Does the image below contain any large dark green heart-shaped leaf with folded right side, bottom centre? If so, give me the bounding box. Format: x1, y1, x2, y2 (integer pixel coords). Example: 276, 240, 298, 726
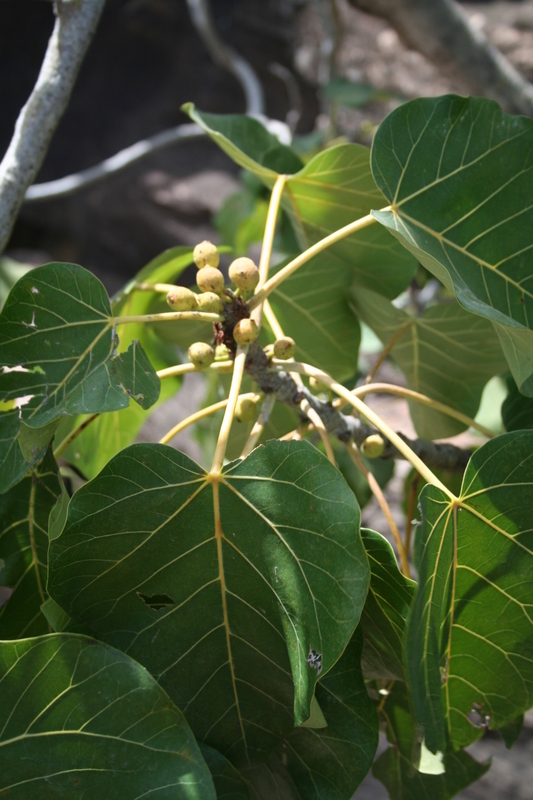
48, 442, 368, 766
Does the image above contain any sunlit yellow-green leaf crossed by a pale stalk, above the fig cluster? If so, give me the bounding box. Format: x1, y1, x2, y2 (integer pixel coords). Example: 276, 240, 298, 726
283, 144, 416, 298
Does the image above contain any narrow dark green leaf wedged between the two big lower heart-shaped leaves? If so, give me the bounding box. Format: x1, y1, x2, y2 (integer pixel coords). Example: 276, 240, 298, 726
361, 528, 416, 680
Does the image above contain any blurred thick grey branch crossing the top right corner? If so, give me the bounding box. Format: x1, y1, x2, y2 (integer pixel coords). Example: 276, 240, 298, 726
348, 0, 533, 116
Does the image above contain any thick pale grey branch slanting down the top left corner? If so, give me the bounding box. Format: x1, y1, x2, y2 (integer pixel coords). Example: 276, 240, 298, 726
0, 0, 105, 252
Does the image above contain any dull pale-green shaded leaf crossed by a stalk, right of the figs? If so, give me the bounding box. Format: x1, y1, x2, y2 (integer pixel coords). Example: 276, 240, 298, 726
352, 289, 506, 439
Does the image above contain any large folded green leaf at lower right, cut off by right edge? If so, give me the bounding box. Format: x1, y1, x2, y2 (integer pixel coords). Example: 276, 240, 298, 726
406, 431, 533, 752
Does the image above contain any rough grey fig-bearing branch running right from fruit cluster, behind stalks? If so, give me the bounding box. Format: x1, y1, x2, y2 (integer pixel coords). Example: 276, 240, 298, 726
246, 344, 472, 472
